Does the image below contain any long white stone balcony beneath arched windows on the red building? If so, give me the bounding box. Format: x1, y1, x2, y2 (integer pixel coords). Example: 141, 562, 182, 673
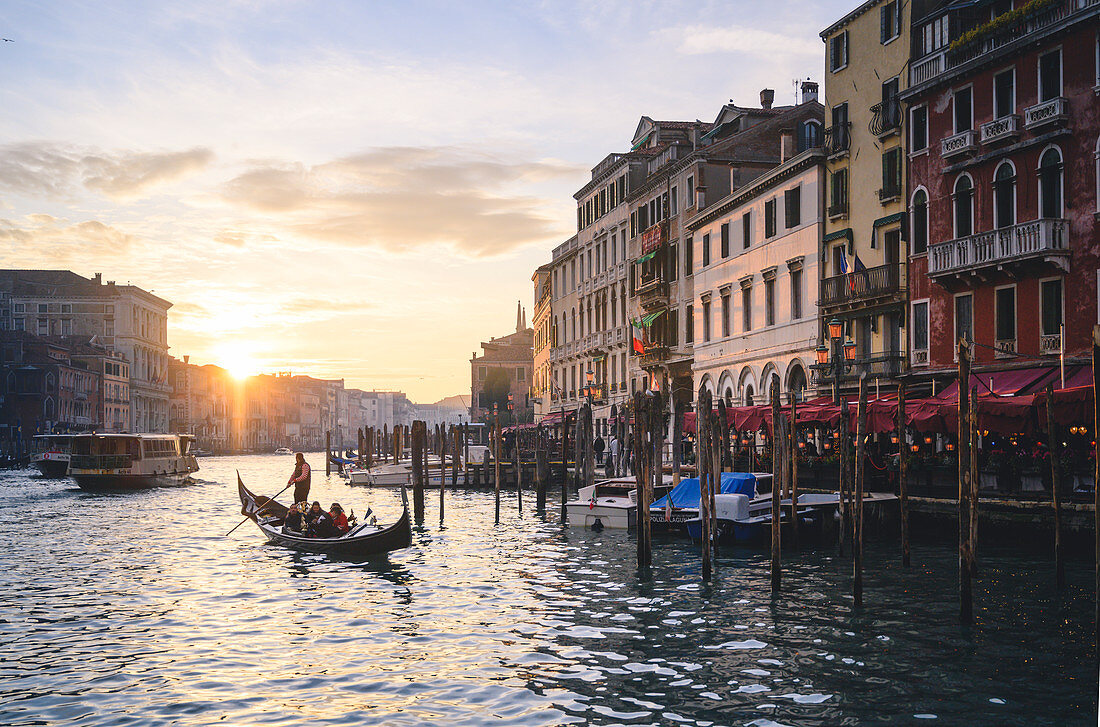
928, 219, 1069, 277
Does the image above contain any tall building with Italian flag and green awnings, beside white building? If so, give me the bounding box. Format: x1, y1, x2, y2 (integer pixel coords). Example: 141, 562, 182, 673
627, 90, 823, 413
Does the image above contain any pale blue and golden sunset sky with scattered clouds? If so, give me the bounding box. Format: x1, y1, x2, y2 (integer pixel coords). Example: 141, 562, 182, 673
0, 0, 856, 401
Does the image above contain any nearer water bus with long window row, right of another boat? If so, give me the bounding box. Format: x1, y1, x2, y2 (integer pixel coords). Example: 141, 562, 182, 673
69, 434, 199, 489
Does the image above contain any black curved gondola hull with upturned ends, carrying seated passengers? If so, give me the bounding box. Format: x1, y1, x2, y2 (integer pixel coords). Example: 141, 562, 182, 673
237, 474, 413, 558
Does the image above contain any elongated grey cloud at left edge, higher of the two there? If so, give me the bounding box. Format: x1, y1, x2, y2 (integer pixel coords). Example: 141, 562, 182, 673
0, 142, 213, 200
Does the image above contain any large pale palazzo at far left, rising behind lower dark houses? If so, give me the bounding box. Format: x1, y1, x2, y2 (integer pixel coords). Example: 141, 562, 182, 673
0, 271, 172, 432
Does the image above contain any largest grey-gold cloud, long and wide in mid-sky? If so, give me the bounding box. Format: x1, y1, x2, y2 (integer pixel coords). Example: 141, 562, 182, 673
222, 146, 583, 257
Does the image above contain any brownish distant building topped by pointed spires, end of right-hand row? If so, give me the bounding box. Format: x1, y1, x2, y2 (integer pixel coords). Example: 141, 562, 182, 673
470, 305, 535, 422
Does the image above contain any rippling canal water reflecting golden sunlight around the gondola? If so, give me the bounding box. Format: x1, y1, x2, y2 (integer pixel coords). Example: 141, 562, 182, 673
0, 455, 1098, 727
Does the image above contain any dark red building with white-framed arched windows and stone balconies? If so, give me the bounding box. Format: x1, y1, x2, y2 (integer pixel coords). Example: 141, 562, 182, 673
902, 0, 1100, 386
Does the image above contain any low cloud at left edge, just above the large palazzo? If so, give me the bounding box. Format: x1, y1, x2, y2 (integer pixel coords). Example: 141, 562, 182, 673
0, 214, 138, 258
